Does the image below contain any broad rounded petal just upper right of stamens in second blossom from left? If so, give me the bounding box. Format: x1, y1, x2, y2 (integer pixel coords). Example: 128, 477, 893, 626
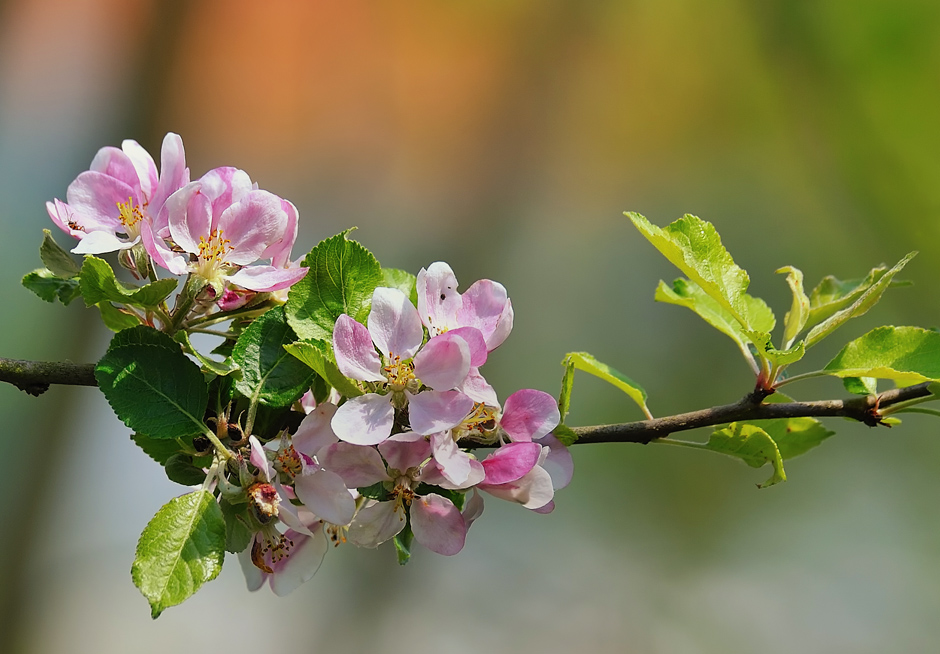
216, 191, 287, 266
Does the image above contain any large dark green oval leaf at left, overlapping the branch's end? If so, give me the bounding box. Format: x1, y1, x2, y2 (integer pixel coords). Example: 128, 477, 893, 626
95, 325, 209, 438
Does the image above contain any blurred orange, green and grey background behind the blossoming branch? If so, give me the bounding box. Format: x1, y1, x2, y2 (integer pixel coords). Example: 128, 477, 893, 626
0, 0, 940, 654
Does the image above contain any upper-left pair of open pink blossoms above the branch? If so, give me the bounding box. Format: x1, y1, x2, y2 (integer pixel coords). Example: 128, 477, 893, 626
46, 133, 307, 310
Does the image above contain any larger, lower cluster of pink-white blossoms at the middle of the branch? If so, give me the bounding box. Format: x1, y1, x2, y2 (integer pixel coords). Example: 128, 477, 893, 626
235, 262, 573, 594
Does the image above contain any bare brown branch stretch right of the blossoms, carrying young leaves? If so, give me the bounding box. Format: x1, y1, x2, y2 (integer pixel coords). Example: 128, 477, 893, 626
572, 382, 932, 444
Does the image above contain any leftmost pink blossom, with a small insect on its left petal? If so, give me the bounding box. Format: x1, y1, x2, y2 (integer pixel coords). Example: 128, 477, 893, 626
46, 132, 189, 254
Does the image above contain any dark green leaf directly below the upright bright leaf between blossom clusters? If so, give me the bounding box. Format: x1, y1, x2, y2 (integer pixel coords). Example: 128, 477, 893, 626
232, 307, 313, 407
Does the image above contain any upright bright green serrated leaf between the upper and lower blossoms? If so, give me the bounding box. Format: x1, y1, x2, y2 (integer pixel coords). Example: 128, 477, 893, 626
285, 230, 385, 341
